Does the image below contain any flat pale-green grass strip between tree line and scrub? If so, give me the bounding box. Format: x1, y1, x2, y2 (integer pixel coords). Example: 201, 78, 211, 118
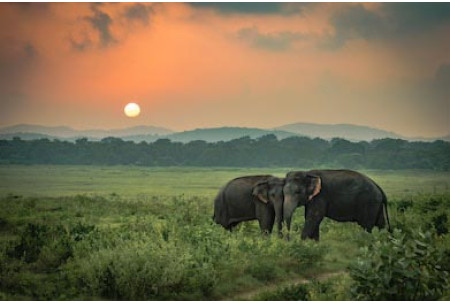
0, 165, 450, 198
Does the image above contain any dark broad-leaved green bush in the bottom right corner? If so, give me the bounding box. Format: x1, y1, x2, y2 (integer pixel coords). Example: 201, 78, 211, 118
349, 229, 449, 300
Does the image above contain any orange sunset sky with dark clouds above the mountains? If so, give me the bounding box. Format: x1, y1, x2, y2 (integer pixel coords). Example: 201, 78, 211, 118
0, 3, 450, 137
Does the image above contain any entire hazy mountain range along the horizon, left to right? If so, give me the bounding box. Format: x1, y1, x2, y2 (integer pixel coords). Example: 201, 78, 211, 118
0, 123, 450, 142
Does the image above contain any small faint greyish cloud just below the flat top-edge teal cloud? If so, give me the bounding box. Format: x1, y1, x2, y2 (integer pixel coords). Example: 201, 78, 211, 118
238, 27, 304, 51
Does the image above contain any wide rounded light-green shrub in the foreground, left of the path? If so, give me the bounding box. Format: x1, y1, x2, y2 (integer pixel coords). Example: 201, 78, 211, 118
66, 238, 219, 300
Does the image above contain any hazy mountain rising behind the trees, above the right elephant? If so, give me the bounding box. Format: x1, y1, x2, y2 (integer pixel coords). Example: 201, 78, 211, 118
275, 123, 407, 141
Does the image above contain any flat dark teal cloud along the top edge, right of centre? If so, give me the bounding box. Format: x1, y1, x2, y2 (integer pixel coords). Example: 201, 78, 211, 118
190, 2, 306, 15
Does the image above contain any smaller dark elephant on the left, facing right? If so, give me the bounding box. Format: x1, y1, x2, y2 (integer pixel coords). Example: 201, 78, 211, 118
213, 175, 284, 234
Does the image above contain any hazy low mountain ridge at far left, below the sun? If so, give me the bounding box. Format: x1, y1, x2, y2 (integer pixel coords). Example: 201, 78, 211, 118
0, 124, 172, 139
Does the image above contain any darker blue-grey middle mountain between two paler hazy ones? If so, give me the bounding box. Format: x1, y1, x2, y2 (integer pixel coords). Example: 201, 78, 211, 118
164, 127, 297, 142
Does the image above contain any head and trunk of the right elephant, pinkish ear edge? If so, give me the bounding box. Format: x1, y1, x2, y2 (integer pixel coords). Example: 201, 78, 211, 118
283, 171, 322, 231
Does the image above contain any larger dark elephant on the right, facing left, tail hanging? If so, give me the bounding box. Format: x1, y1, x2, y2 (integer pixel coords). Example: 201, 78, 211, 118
283, 170, 390, 241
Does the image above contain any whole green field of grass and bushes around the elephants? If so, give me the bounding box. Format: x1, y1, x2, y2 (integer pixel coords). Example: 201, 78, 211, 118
0, 165, 450, 300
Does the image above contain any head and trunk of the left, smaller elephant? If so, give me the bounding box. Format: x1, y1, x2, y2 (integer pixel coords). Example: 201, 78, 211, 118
253, 177, 285, 234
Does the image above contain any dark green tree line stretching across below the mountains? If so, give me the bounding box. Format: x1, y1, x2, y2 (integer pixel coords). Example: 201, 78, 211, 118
0, 135, 450, 171
